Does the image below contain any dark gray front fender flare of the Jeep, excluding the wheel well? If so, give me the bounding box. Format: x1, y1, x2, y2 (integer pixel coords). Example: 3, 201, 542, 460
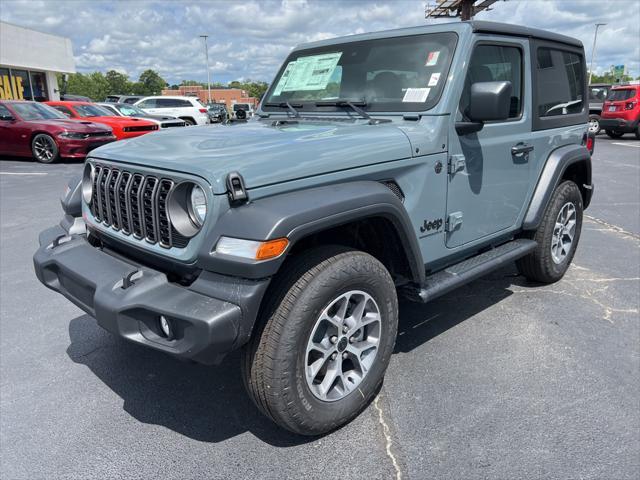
197, 181, 425, 282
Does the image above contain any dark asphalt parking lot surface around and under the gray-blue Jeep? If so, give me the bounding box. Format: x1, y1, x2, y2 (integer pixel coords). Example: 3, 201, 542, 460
0, 135, 640, 480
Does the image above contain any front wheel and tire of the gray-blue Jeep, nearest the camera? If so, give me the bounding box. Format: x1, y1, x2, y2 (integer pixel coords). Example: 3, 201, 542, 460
242, 247, 398, 435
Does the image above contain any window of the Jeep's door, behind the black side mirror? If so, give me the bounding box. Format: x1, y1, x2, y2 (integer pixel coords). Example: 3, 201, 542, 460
460, 45, 522, 118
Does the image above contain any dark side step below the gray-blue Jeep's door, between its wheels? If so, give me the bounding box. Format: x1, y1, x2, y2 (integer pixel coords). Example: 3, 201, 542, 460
411, 238, 537, 302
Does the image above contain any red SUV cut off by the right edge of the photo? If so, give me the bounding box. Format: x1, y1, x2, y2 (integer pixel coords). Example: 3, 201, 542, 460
600, 85, 640, 140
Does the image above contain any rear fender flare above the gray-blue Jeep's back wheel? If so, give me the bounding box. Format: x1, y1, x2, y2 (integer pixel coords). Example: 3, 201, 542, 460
522, 145, 593, 230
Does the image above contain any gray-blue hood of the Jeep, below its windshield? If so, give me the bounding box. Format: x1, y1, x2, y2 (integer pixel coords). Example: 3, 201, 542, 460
91, 119, 411, 193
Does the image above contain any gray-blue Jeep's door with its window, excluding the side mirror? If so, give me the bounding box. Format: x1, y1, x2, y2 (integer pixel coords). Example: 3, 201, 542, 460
446, 37, 535, 248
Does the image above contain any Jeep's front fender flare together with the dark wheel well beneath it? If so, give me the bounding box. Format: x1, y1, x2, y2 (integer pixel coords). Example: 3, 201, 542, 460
198, 181, 424, 283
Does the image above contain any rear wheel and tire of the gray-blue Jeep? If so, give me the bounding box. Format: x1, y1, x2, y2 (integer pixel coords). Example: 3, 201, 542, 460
516, 181, 583, 283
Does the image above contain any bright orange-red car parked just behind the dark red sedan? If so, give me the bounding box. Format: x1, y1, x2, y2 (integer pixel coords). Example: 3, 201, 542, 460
45, 102, 158, 140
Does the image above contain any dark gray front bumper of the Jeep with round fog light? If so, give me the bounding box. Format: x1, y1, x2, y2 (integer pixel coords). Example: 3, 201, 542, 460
33, 227, 269, 364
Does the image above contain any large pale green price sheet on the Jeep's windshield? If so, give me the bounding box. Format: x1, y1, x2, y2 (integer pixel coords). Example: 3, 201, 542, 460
274, 52, 342, 95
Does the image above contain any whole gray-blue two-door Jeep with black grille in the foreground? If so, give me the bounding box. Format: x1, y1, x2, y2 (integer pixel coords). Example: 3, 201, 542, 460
34, 22, 593, 435
